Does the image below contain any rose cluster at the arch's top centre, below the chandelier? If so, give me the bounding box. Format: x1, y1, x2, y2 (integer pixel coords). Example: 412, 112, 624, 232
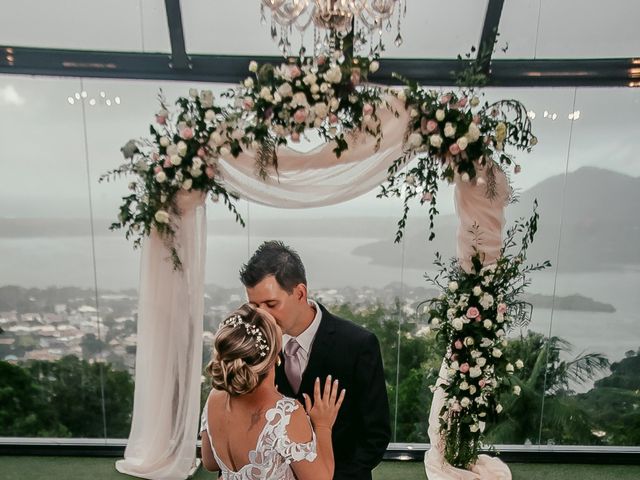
224, 52, 382, 176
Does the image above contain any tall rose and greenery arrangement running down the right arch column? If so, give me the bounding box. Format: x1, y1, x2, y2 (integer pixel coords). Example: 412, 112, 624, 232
426, 202, 550, 469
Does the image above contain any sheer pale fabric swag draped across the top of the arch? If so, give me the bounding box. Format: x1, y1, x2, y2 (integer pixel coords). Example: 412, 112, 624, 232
219, 97, 409, 208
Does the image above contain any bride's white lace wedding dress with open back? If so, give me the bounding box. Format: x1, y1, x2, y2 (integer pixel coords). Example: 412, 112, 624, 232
200, 397, 316, 480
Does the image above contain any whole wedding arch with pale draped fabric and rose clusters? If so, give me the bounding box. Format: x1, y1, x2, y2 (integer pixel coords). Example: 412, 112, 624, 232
101, 57, 545, 480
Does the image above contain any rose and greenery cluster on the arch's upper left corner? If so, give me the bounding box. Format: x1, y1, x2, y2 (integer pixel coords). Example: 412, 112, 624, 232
100, 89, 244, 269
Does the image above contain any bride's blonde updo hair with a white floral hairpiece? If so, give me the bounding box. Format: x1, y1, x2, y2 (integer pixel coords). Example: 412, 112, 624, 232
206, 303, 282, 396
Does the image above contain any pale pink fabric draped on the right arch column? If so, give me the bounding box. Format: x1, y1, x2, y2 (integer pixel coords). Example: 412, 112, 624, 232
424, 168, 511, 480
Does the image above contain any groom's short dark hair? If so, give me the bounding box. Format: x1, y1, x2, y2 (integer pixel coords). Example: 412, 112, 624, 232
240, 240, 307, 293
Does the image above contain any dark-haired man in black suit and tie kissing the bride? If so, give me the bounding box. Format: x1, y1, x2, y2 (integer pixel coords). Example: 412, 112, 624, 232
240, 241, 391, 480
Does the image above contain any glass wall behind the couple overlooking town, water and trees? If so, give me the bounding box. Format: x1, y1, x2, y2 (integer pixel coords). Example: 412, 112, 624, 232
0, 76, 640, 446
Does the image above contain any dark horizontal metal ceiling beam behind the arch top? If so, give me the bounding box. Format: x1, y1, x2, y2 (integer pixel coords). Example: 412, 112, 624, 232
0, 46, 640, 87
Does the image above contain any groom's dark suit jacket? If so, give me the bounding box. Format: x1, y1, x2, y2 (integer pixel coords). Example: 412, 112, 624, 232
276, 305, 391, 480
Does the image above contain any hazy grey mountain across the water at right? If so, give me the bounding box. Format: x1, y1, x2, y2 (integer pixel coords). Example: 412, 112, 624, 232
353, 167, 640, 272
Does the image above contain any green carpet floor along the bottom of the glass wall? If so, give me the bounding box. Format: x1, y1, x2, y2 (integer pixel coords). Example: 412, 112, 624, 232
0, 456, 640, 480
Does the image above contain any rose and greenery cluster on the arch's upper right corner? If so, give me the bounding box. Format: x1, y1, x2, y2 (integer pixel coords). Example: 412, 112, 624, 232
378, 77, 538, 242
